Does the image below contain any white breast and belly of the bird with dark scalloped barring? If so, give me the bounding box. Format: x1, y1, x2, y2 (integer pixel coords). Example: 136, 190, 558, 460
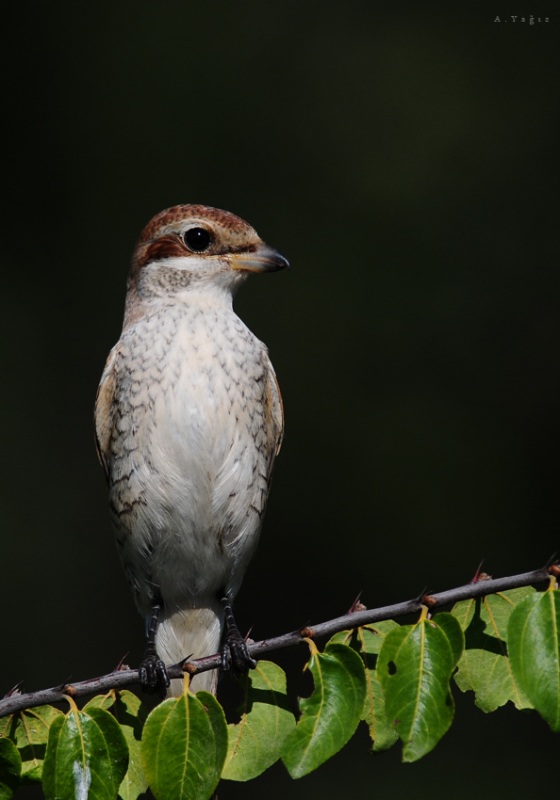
103, 297, 277, 611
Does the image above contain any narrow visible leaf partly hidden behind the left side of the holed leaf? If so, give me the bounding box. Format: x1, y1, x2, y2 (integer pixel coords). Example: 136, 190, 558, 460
329, 620, 399, 753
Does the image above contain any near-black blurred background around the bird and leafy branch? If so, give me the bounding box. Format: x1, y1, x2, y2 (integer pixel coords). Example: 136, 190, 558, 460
0, 0, 560, 800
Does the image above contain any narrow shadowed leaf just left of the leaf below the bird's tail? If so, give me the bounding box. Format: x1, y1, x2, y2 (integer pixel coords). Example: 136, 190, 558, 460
111, 689, 148, 800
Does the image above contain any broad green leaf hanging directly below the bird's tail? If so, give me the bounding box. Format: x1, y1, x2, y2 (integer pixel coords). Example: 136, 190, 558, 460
141, 692, 227, 800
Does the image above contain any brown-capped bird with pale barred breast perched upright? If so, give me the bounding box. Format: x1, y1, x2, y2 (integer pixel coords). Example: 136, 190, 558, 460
95, 204, 289, 696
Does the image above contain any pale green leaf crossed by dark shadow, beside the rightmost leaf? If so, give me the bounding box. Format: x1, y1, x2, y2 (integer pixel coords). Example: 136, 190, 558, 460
451, 586, 535, 712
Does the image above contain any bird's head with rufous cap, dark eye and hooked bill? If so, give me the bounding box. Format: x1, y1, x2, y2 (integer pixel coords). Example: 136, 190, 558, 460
129, 205, 288, 314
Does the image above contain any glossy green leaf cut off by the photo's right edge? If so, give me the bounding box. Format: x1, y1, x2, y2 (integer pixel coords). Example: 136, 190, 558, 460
508, 584, 560, 731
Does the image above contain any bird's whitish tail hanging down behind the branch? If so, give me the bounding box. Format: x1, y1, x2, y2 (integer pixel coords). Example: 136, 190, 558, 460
156, 601, 224, 697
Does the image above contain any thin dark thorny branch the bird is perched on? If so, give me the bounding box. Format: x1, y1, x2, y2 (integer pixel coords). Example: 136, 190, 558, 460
0, 562, 560, 717
